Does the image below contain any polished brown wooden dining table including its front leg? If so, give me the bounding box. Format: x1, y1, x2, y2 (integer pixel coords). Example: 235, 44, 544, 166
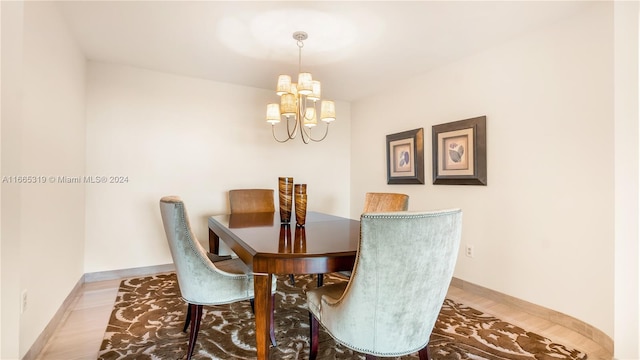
208, 211, 360, 360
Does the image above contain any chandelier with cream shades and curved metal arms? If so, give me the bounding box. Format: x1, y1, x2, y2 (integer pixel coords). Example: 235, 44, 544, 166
267, 31, 336, 144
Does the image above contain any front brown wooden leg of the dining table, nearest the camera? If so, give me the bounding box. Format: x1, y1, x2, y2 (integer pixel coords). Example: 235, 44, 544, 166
253, 274, 273, 360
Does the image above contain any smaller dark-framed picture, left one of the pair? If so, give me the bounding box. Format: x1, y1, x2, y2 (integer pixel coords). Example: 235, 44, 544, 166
387, 128, 424, 184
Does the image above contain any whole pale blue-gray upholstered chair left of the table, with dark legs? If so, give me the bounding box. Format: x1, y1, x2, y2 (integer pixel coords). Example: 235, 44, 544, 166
160, 196, 276, 359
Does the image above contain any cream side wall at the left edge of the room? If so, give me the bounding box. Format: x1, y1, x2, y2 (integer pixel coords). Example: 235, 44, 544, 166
2, 2, 85, 359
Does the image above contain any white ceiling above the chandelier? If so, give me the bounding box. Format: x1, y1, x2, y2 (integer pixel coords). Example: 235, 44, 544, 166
56, 0, 591, 101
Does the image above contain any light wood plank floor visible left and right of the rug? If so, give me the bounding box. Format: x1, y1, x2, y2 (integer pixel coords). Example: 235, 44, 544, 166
36, 274, 612, 360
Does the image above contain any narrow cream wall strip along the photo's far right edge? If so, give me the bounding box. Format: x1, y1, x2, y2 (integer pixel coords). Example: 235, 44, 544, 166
614, 1, 640, 359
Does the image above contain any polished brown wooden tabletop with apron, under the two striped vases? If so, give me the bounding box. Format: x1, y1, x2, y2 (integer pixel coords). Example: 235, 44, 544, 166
209, 211, 360, 274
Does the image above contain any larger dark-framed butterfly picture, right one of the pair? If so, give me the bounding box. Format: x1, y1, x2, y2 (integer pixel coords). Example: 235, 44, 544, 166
431, 116, 487, 186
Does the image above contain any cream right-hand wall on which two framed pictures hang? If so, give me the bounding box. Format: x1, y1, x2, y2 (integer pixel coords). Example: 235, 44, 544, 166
351, 4, 614, 336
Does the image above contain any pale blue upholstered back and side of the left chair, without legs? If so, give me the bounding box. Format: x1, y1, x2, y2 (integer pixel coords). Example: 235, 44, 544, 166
160, 196, 253, 304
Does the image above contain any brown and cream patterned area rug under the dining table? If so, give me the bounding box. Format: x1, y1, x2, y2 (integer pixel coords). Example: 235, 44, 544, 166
99, 273, 586, 360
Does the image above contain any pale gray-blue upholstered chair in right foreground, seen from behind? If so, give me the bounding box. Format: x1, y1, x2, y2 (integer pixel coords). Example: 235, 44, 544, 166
307, 209, 462, 359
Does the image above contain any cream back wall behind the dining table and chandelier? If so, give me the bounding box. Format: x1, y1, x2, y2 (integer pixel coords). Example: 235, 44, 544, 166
85, 62, 350, 273
